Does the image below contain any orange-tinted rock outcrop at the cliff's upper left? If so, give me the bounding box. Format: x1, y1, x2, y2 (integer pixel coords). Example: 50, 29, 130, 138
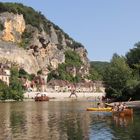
0, 12, 25, 42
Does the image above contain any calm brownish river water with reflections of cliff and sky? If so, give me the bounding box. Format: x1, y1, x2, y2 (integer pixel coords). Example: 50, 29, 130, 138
0, 101, 140, 140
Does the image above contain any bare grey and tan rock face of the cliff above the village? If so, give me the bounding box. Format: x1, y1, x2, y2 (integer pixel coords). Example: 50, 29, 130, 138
0, 3, 89, 79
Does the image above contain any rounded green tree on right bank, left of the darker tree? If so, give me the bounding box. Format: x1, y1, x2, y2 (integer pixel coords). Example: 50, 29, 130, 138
104, 54, 132, 99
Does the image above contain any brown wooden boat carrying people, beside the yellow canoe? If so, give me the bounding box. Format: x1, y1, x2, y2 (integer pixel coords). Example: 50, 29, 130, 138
112, 108, 133, 117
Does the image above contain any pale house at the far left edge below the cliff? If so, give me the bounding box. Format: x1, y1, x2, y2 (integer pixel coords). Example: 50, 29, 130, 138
0, 63, 10, 86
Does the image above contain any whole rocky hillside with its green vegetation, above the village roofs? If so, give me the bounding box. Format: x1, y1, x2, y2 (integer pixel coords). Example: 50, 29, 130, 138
0, 2, 89, 87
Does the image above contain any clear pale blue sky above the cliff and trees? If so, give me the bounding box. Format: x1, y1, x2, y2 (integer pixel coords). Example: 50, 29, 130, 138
0, 0, 140, 61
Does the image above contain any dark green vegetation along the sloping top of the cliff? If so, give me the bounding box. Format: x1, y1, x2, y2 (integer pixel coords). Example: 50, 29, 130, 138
0, 2, 84, 49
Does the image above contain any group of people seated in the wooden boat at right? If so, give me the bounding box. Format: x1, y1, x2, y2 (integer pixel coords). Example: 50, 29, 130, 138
113, 102, 127, 111
